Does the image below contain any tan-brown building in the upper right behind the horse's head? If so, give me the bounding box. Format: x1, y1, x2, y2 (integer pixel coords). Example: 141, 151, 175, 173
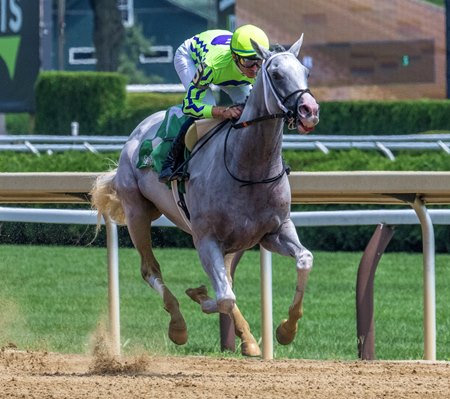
235, 0, 446, 101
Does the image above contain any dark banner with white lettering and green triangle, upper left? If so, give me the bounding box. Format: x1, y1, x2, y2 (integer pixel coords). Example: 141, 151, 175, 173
0, 0, 40, 112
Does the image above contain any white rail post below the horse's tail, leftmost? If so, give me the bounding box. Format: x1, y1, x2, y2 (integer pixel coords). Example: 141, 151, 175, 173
103, 216, 120, 356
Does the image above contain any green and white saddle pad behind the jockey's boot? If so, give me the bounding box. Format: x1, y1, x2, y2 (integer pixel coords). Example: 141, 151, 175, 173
136, 105, 188, 173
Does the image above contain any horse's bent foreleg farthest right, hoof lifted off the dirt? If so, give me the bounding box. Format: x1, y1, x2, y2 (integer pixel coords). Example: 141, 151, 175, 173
261, 219, 313, 345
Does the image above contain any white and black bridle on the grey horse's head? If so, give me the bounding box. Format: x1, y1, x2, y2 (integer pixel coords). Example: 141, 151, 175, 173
232, 51, 314, 130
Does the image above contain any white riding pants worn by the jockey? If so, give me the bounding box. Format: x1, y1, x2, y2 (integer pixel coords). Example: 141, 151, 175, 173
173, 39, 252, 105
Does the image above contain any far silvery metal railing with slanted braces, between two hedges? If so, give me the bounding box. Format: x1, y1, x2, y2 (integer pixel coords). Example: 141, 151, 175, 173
0, 133, 450, 161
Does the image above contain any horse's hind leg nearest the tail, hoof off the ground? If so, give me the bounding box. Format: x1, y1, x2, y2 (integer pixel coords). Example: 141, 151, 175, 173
122, 189, 188, 345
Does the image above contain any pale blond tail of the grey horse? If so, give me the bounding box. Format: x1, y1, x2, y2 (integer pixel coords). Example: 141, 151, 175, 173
90, 169, 126, 231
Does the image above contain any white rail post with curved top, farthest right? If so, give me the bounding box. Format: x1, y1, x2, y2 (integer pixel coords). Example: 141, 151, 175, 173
411, 197, 436, 360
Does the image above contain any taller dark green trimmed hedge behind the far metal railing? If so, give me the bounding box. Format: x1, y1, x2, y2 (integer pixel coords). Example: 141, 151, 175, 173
30, 72, 450, 135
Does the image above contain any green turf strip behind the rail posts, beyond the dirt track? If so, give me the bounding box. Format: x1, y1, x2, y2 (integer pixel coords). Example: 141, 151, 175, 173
0, 245, 450, 360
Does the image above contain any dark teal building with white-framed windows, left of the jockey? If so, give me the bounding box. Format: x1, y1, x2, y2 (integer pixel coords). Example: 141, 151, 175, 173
52, 0, 217, 83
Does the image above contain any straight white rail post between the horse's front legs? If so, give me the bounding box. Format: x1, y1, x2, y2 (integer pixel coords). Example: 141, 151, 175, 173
259, 246, 273, 360
